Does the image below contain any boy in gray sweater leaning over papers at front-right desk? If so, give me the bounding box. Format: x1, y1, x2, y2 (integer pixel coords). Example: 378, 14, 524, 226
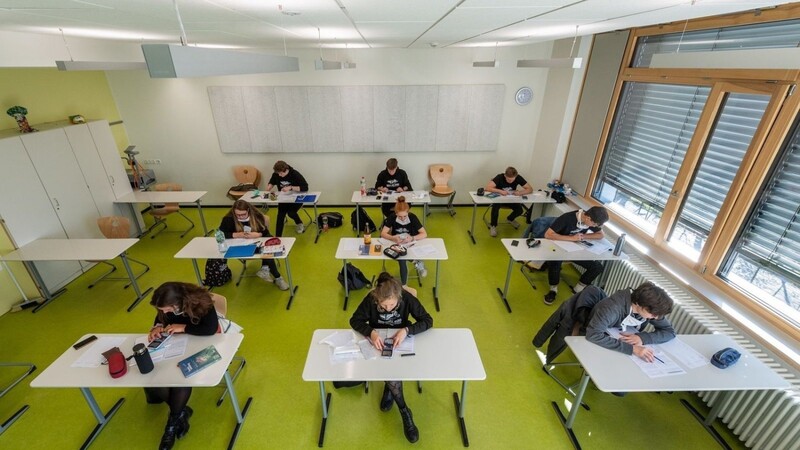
586, 281, 675, 362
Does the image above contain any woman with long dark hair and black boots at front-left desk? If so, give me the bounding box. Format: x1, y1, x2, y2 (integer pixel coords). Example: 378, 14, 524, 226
144, 281, 221, 450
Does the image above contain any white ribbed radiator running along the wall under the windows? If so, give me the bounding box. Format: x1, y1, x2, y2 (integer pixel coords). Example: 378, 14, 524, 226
598, 254, 800, 450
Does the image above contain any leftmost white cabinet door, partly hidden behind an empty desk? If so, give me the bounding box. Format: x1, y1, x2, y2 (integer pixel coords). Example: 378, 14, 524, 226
0, 137, 81, 291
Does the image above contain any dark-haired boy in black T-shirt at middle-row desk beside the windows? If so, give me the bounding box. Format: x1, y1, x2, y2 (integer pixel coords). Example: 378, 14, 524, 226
544, 206, 608, 305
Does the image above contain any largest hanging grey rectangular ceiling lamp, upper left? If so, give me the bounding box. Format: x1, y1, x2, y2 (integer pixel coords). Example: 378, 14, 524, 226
142, 44, 300, 78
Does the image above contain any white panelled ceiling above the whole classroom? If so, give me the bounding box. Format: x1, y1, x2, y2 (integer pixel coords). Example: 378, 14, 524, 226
0, 0, 789, 49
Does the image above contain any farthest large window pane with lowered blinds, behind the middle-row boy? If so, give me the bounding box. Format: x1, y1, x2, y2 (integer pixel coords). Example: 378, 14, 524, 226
593, 82, 711, 236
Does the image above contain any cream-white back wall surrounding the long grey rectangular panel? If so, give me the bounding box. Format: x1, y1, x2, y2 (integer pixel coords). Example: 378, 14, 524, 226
107, 43, 581, 204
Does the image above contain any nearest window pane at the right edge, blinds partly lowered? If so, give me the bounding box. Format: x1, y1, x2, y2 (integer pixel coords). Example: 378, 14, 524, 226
720, 118, 800, 324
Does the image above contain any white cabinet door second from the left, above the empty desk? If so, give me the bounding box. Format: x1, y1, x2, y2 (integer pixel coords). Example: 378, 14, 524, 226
21, 128, 103, 239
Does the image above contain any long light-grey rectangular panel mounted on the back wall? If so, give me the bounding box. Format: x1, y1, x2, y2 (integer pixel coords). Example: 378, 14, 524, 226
208, 84, 505, 153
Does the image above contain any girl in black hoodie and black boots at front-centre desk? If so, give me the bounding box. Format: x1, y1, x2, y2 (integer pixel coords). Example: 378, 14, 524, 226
350, 272, 433, 443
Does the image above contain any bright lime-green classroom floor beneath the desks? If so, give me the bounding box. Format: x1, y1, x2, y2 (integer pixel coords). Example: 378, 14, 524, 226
0, 207, 745, 450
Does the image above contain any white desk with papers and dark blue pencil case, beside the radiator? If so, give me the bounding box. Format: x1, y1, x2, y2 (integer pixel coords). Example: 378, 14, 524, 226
552, 334, 791, 448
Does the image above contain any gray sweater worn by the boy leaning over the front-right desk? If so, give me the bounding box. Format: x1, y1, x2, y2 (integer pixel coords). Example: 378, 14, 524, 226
586, 289, 675, 355
